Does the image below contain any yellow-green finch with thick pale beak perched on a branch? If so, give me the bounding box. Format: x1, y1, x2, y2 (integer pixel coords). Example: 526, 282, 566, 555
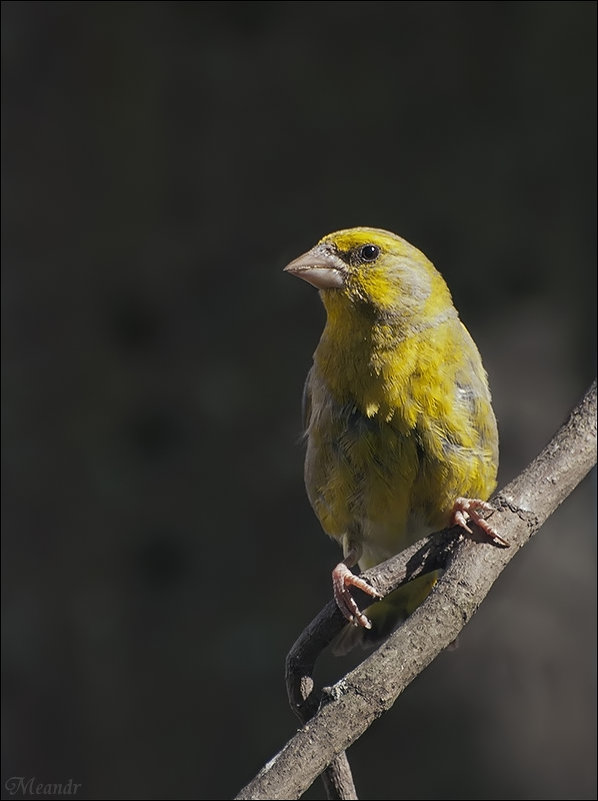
284, 227, 508, 653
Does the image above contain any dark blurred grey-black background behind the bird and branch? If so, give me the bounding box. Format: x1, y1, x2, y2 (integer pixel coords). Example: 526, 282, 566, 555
2, 2, 596, 799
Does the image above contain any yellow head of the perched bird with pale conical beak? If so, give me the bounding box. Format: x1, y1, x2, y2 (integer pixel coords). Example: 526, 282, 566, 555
285, 228, 452, 321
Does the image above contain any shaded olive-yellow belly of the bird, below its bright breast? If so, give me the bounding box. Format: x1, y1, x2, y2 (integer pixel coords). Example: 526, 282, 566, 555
305, 388, 496, 569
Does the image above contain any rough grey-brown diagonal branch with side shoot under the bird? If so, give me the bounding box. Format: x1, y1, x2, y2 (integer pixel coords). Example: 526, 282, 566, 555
237, 382, 596, 799
